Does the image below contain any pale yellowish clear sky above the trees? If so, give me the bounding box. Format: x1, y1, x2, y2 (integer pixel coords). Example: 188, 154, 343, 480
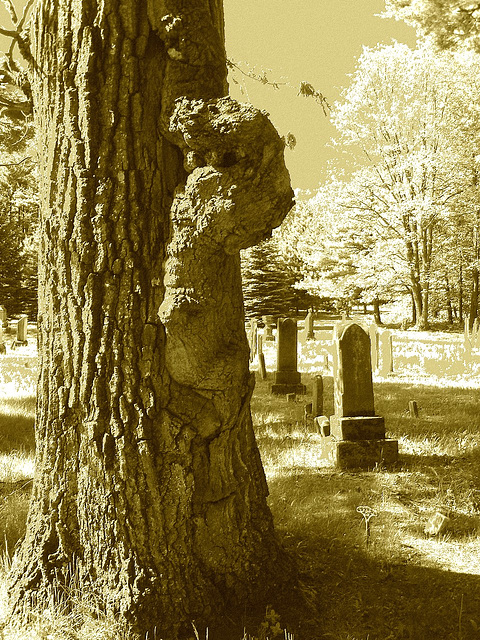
0, 0, 415, 189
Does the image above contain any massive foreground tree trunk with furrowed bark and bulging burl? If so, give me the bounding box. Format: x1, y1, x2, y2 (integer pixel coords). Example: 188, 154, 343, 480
11, 0, 292, 639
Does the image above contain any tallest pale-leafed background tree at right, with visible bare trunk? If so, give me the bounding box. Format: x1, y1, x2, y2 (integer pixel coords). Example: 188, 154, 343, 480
334, 44, 479, 328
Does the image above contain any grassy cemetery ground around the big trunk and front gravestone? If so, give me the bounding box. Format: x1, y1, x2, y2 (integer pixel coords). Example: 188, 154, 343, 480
0, 340, 480, 640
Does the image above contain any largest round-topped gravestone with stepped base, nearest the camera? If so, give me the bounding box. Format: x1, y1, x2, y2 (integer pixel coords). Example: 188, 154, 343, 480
322, 324, 398, 469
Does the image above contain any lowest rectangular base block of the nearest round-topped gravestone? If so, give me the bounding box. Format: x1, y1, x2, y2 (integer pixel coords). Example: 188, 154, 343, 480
320, 436, 398, 469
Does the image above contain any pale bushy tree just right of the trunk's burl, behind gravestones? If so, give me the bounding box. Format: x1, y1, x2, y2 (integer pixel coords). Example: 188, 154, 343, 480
275, 178, 399, 323
